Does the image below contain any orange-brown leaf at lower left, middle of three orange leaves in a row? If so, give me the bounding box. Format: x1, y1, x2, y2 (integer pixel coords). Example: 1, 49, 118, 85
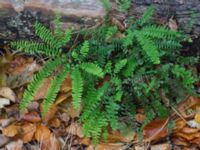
21, 123, 36, 143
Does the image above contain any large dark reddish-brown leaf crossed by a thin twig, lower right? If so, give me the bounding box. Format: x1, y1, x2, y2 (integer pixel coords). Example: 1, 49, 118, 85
143, 119, 169, 142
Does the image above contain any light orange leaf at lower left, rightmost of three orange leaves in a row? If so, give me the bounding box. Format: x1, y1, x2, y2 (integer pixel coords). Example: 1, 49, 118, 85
35, 125, 51, 142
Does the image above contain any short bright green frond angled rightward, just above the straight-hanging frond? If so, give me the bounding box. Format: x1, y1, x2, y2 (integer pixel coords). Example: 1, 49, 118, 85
80, 63, 104, 78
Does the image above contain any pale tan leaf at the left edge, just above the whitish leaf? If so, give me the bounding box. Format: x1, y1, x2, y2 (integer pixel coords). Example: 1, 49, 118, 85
0, 87, 16, 102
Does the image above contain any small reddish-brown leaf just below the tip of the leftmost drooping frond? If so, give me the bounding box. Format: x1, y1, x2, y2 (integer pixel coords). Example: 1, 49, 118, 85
23, 112, 41, 123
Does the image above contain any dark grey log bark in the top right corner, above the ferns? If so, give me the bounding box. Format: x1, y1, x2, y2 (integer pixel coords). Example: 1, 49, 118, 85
130, 0, 200, 37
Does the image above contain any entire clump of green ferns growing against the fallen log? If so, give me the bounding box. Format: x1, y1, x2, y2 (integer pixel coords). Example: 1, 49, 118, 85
11, 5, 197, 143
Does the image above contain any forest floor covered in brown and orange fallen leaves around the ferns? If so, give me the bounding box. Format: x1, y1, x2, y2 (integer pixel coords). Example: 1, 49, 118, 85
0, 41, 200, 150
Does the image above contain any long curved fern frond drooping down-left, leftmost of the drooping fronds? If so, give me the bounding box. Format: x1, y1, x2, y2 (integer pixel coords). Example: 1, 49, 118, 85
20, 59, 62, 111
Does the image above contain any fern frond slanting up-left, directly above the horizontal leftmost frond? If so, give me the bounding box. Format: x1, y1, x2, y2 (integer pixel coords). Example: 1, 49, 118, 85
34, 22, 60, 49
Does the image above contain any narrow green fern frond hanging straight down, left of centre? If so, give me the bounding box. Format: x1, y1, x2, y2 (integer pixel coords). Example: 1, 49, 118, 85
71, 68, 83, 109
